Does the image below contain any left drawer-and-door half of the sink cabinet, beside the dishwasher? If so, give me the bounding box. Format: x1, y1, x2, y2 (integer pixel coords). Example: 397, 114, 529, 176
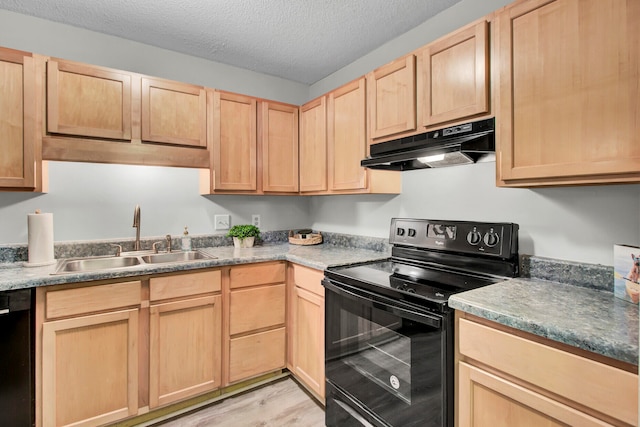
36, 281, 141, 427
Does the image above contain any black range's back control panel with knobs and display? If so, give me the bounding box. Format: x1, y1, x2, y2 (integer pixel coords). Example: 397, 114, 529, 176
389, 218, 518, 258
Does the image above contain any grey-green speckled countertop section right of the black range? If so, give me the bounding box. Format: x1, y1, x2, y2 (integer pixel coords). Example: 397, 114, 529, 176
449, 278, 639, 365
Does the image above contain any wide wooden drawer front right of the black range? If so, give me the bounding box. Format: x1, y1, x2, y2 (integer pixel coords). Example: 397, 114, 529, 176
459, 319, 638, 425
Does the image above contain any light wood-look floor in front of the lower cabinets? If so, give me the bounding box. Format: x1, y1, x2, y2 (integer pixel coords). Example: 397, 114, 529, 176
158, 378, 324, 427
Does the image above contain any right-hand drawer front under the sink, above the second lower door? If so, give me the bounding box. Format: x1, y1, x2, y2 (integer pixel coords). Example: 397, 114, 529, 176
149, 270, 221, 301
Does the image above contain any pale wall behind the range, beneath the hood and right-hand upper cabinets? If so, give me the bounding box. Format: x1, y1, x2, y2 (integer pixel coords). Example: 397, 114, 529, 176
309, 162, 640, 265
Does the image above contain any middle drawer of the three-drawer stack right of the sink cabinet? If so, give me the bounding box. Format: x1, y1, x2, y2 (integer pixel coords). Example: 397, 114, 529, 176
229, 284, 286, 335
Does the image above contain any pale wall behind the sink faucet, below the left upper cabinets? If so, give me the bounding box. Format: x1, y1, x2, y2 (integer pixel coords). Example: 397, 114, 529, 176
0, 162, 309, 245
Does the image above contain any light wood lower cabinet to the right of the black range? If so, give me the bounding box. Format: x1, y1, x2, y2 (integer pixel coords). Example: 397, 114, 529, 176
456, 316, 638, 427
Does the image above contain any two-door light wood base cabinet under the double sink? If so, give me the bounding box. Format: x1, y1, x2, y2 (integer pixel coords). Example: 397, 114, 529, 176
36, 269, 222, 427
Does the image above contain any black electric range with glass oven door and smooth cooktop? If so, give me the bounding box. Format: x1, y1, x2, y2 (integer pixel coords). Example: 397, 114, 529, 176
323, 218, 518, 427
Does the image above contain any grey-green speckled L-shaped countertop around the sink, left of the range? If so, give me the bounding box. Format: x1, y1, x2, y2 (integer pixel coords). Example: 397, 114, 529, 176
0, 243, 389, 291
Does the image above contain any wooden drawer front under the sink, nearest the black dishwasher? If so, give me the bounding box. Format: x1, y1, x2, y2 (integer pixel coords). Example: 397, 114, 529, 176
46, 281, 141, 319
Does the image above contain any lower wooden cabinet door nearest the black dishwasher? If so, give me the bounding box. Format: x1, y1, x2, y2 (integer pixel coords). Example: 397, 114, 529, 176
42, 309, 139, 427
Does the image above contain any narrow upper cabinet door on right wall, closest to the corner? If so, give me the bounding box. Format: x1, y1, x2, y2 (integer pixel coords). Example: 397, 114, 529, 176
300, 96, 327, 192
